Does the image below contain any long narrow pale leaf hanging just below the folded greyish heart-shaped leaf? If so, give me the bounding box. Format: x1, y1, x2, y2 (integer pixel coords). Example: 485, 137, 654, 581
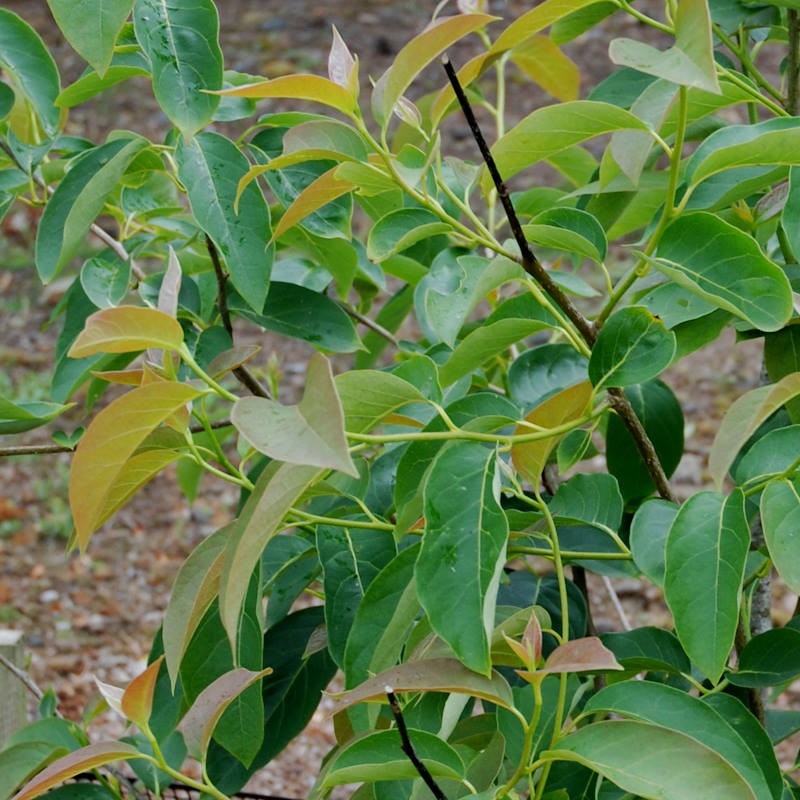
219, 462, 321, 644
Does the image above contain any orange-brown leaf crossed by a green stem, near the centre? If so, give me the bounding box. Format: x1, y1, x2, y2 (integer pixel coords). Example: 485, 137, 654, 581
511, 381, 592, 484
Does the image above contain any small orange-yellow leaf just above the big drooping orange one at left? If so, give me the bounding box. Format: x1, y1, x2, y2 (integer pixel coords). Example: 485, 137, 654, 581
67, 306, 183, 358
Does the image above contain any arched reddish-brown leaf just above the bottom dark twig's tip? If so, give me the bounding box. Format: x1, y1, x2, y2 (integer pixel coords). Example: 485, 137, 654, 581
334, 658, 514, 711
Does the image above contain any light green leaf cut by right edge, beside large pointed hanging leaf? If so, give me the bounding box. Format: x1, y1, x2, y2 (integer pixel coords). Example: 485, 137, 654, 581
761, 482, 800, 592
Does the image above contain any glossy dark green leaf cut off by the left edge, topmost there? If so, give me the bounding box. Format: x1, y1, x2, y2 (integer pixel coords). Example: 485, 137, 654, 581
0, 8, 61, 137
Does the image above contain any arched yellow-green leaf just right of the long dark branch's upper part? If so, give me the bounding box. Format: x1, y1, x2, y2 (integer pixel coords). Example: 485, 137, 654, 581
488, 100, 648, 193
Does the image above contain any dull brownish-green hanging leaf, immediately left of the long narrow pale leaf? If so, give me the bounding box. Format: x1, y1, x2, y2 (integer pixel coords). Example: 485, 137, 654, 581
163, 527, 230, 688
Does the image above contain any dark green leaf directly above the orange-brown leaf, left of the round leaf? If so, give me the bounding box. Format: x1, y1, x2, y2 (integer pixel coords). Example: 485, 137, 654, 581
508, 343, 588, 410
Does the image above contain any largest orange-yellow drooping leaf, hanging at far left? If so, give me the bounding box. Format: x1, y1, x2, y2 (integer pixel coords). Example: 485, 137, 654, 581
69, 381, 200, 549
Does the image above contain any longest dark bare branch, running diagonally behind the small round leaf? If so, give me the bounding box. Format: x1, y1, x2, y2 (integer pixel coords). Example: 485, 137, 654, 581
443, 56, 675, 500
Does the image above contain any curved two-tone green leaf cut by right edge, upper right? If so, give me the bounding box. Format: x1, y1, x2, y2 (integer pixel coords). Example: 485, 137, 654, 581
685, 117, 800, 186
